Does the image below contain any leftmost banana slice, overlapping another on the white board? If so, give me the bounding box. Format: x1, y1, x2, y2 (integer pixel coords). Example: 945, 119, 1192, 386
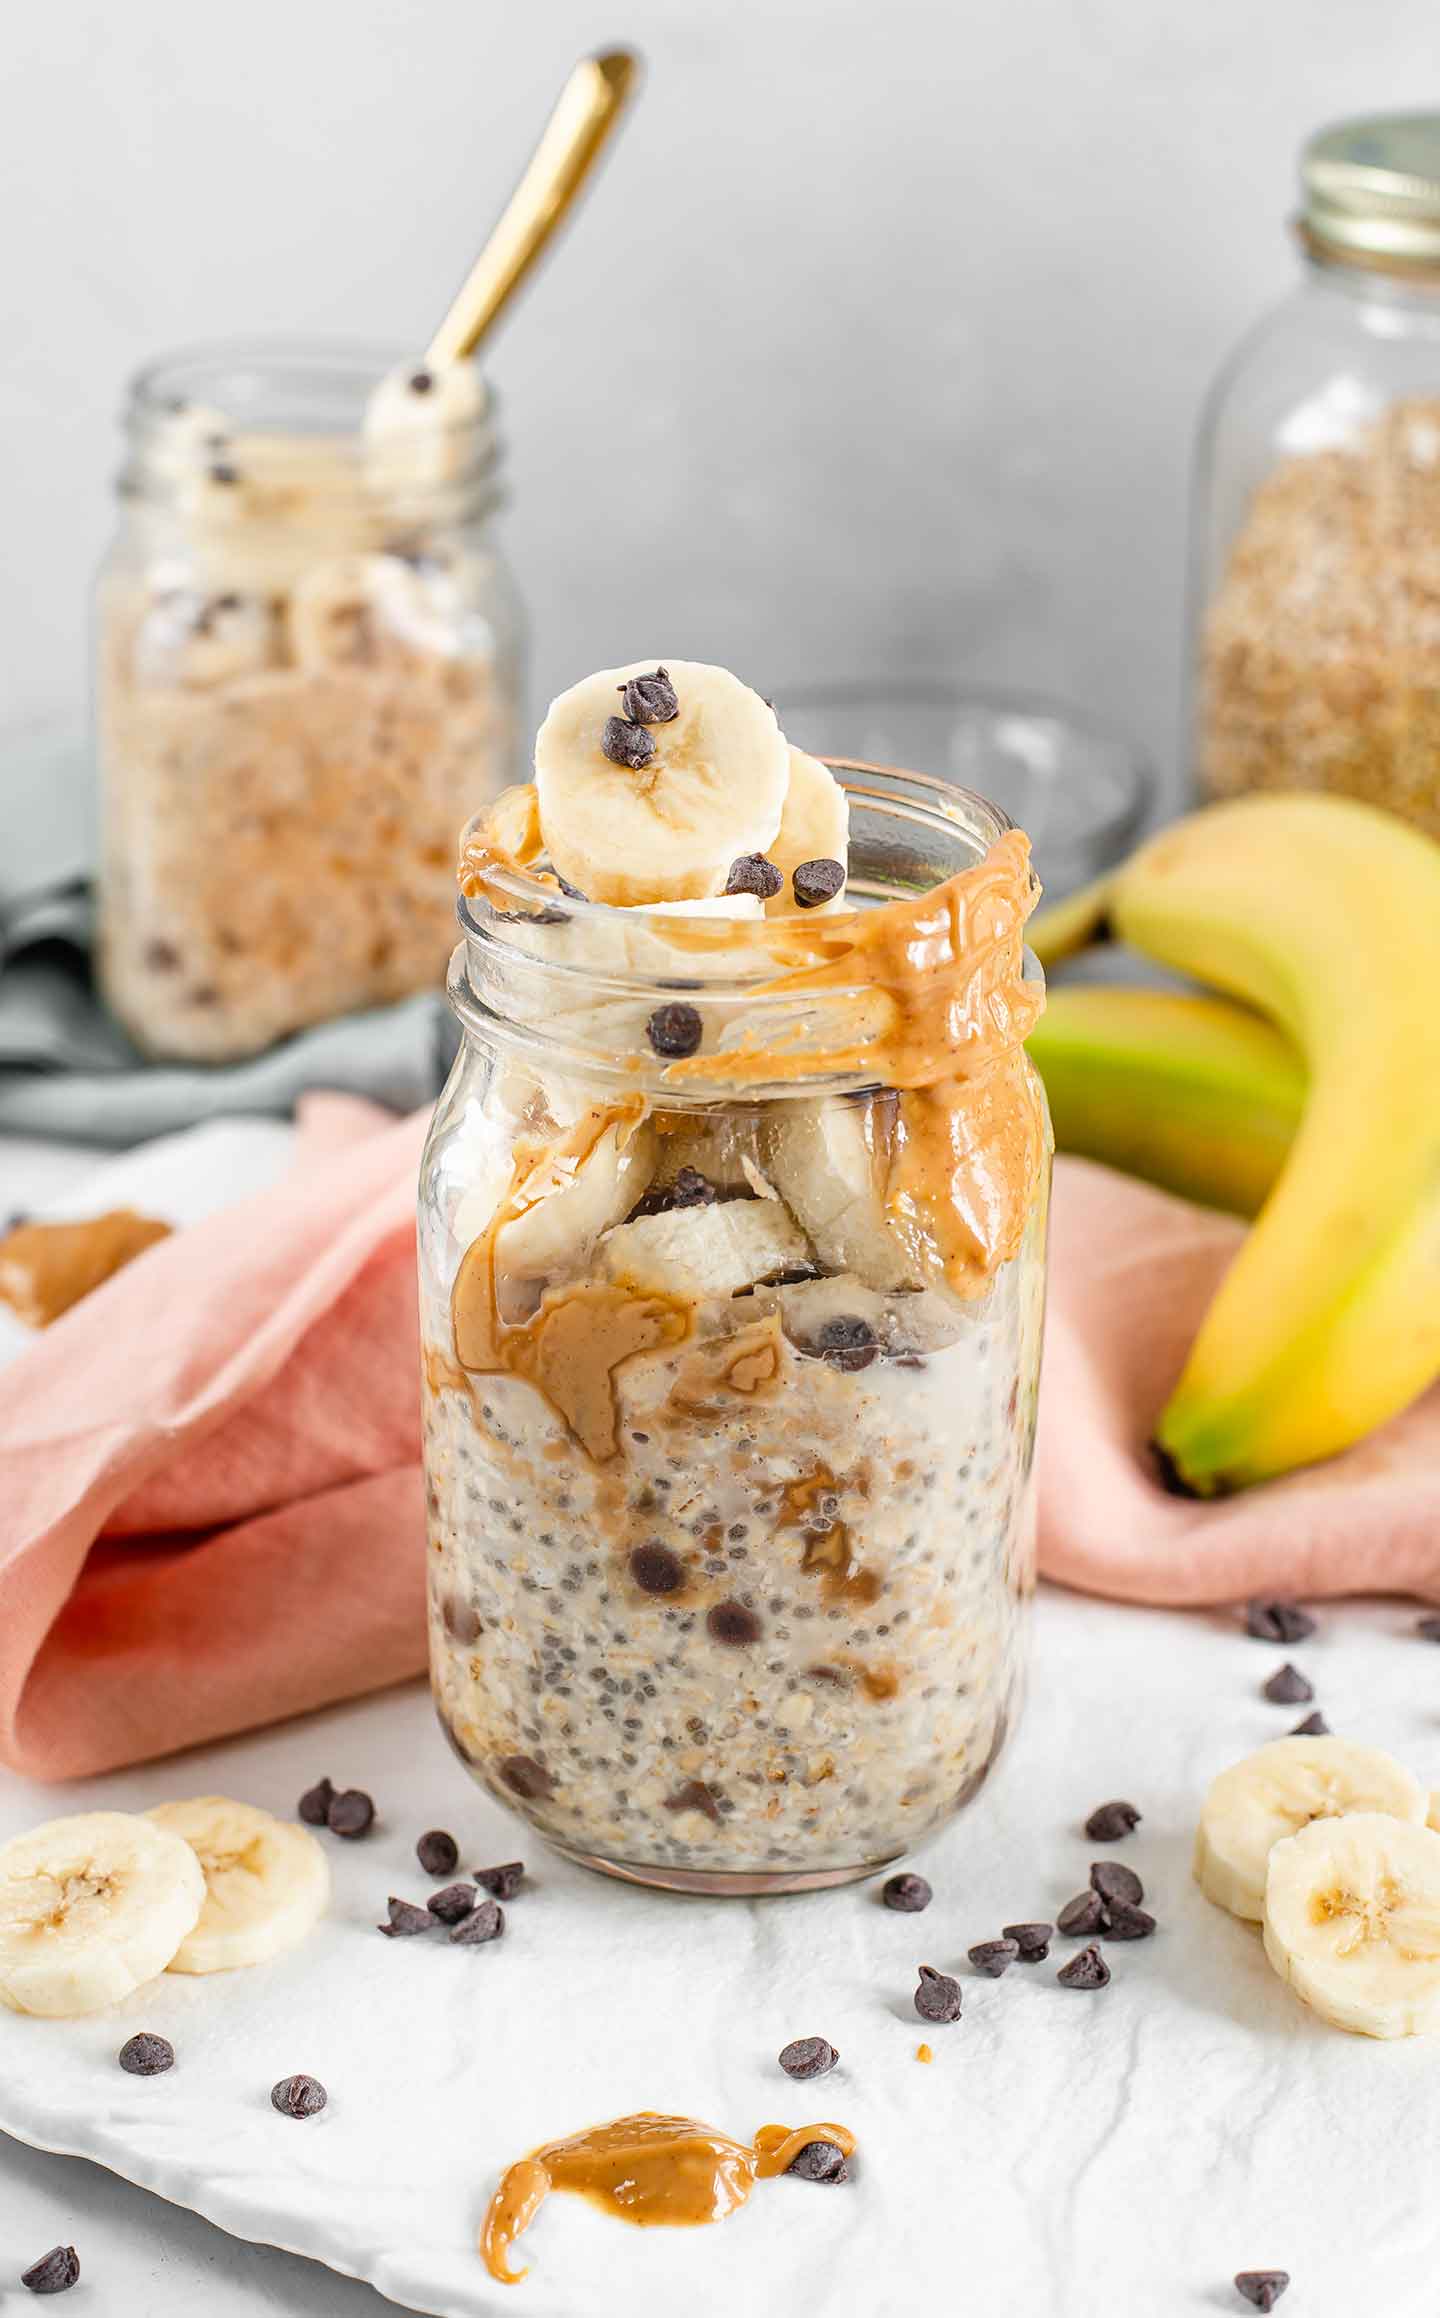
0, 1810, 204, 2019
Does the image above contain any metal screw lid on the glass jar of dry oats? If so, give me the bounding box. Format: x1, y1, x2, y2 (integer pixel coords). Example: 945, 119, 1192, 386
1301, 114, 1440, 267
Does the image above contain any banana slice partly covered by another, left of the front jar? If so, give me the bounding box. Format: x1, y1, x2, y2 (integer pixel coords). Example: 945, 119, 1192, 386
146, 1794, 329, 1973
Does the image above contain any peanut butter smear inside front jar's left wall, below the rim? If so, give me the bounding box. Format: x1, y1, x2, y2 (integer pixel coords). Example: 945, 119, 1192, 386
450, 1094, 691, 1465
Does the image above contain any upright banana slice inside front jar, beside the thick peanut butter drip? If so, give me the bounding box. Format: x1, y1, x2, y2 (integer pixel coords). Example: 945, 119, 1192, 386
761, 1101, 921, 1293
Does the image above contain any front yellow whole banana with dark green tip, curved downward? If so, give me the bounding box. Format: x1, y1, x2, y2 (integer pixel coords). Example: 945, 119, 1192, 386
1108, 795, 1440, 1495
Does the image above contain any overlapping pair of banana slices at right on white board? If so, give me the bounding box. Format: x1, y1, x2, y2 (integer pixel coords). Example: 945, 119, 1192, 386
1194, 1739, 1440, 2038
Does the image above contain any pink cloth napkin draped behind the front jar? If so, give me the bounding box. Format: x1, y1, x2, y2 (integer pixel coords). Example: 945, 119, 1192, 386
0, 1126, 1440, 1778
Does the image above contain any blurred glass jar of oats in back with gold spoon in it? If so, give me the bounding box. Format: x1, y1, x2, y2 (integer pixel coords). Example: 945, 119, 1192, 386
95, 345, 522, 1062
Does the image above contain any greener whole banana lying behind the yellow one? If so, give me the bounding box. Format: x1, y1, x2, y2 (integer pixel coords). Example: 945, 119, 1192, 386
1027, 983, 1306, 1215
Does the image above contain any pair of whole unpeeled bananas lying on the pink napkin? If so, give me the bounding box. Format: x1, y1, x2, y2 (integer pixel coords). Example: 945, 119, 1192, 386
1032, 795, 1440, 1495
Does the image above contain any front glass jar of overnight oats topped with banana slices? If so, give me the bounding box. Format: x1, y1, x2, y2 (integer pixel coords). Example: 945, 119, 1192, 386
420, 661, 1050, 1891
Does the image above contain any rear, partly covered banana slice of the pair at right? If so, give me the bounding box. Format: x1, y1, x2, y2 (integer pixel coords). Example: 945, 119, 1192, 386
1194, 1739, 1428, 1924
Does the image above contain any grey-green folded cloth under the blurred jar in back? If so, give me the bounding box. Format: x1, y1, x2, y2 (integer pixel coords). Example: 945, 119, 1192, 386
0, 874, 454, 1147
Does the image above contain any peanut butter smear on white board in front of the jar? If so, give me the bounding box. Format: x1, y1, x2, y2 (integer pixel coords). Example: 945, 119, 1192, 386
480, 2109, 856, 2286
